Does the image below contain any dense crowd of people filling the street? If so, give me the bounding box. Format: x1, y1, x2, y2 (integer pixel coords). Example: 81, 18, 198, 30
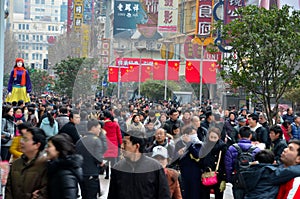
1, 95, 300, 199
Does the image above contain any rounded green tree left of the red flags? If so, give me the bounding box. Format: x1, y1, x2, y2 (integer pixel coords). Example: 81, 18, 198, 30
54, 57, 98, 99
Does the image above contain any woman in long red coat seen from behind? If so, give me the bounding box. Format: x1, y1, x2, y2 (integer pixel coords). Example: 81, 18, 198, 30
103, 110, 122, 179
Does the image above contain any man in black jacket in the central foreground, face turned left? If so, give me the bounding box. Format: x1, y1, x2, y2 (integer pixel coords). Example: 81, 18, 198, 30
108, 131, 170, 199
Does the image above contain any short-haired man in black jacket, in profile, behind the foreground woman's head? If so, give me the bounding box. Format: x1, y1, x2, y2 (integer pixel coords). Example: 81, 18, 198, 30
59, 111, 80, 144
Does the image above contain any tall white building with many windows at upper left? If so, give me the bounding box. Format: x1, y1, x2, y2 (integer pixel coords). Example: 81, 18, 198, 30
8, 0, 67, 69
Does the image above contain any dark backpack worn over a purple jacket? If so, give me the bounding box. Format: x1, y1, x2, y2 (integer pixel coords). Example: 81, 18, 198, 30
232, 143, 257, 190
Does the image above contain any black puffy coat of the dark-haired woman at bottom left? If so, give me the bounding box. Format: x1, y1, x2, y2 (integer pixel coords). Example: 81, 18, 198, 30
47, 155, 83, 199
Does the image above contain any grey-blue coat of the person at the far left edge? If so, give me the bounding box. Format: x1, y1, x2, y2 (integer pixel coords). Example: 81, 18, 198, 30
1, 117, 16, 147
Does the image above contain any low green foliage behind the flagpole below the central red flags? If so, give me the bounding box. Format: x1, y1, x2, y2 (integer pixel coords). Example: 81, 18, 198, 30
141, 80, 180, 100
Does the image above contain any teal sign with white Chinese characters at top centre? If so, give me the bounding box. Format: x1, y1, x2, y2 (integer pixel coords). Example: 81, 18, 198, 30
113, 0, 147, 38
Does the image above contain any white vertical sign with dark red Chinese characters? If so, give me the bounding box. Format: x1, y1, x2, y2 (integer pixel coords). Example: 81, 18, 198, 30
158, 0, 178, 32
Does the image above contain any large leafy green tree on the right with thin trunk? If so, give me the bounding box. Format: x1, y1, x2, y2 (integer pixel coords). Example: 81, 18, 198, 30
219, 6, 300, 123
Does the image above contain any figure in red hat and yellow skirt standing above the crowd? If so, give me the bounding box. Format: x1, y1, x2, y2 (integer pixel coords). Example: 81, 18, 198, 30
6, 58, 31, 103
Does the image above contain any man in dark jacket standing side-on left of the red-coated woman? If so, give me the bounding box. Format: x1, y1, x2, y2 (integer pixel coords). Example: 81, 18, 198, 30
76, 119, 105, 199
